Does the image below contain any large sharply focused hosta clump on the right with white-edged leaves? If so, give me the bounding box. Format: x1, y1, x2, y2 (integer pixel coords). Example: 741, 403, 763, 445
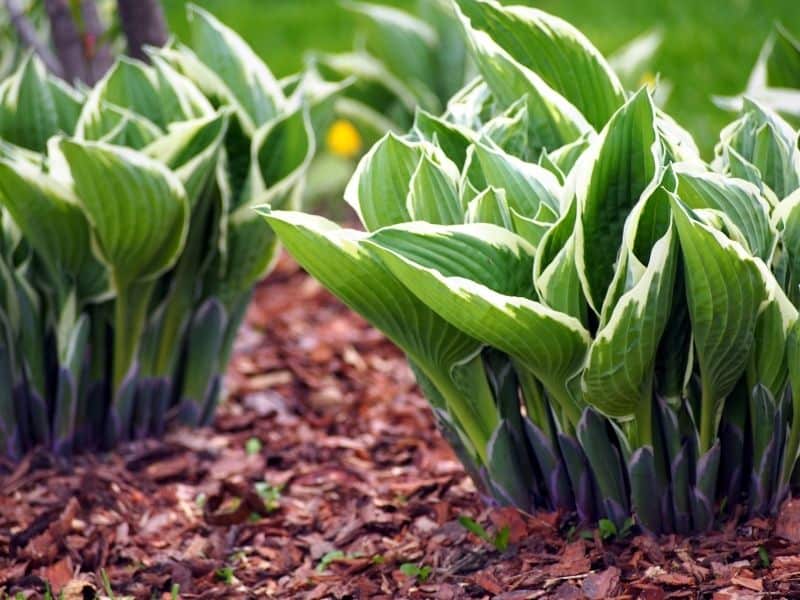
262, 0, 800, 533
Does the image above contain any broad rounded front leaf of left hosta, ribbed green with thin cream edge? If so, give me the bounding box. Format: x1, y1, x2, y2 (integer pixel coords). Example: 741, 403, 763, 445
59, 140, 189, 289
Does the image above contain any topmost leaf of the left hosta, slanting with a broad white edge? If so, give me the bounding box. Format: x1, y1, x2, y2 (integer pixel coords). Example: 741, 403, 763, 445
189, 5, 286, 126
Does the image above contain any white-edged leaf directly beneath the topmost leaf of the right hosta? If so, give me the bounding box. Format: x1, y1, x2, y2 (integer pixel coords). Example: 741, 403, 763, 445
459, 2, 592, 152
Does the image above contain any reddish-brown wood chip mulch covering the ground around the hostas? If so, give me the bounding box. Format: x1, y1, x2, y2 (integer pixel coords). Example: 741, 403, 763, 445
0, 258, 800, 600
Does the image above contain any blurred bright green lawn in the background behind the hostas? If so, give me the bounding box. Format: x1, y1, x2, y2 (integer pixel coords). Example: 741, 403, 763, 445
164, 0, 800, 155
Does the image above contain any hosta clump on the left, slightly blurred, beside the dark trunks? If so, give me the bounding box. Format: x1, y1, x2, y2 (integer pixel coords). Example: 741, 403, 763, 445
0, 9, 326, 457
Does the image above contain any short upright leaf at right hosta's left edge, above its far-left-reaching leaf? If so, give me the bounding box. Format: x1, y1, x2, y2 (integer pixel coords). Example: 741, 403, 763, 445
344, 132, 422, 231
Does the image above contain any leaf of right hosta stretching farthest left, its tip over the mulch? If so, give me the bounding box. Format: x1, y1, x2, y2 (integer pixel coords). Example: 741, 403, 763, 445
265, 211, 498, 459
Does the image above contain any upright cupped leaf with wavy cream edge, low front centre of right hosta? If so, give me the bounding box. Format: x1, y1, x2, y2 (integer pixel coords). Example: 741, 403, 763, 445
582, 228, 678, 418
